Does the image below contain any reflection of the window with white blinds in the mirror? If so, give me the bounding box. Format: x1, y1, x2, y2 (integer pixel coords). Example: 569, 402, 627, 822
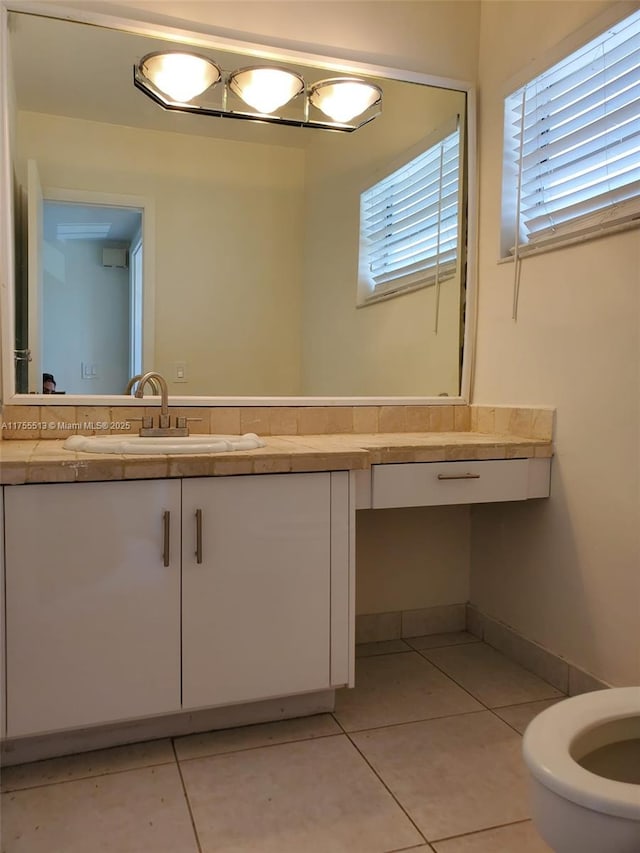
360, 120, 462, 303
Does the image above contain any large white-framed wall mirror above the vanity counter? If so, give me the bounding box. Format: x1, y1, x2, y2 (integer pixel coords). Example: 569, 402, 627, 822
3, 4, 472, 403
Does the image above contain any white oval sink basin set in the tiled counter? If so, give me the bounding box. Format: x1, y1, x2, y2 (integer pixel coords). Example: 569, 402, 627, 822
62, 432, 266, 454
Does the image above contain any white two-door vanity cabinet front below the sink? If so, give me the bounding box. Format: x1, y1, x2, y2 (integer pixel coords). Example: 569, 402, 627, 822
4, 472, 353, 737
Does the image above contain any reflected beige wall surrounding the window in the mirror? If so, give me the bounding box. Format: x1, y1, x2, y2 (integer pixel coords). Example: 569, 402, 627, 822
303, 81, 465, 397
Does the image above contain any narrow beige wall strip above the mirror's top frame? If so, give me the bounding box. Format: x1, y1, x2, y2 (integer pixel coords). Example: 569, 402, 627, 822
48, 0, 480, 80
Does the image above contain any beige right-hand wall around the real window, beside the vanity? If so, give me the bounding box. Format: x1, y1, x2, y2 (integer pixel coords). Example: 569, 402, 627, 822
471, 0, 640, 685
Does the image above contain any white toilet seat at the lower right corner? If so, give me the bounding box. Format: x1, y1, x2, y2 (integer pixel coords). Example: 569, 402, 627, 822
523, 687, 640, 821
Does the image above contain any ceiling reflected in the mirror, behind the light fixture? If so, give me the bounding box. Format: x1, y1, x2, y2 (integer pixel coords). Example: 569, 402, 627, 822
9, 12, 384, 148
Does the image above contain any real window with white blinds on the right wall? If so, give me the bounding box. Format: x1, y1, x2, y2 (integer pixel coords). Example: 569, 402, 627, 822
502, 12, 640, 256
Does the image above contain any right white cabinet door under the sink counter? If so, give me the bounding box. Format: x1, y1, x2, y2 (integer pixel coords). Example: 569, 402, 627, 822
182, 473, 331, 708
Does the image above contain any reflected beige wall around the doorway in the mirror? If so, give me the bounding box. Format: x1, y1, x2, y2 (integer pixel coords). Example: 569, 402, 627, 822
18, 113, 305, 396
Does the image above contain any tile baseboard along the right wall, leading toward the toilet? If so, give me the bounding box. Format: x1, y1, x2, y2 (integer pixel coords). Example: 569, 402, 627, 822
466, 604, 611, 696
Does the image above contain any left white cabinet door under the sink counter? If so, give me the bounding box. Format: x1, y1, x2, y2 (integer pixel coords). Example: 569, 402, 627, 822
5, 480, 180, 737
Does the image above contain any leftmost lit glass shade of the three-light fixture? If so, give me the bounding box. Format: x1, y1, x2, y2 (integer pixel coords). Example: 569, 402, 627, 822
139, 53, 220, 103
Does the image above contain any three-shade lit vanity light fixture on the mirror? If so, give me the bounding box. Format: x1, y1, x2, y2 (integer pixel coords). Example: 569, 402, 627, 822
133, 50, 382, 132
